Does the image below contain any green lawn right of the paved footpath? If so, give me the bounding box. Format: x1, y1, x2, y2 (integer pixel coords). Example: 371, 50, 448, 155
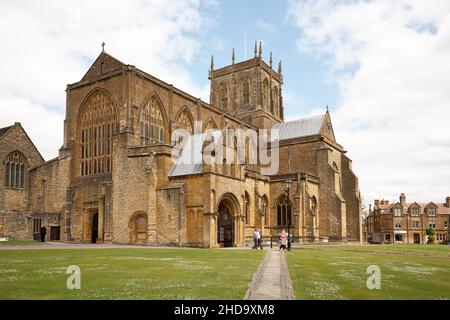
286, 245, 450, 300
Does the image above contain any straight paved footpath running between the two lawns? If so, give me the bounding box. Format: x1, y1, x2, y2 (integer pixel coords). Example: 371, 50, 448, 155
244, 249, 294, 300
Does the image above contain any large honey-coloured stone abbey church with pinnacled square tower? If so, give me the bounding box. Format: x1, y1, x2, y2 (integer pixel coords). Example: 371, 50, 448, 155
0, 43, 362, 248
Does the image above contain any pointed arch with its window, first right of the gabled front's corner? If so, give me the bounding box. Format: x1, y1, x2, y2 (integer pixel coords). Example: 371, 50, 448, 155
139, 92, 168, 145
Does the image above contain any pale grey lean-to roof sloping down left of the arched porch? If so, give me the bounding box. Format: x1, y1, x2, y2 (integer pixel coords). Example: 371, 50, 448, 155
169, 130, 222, 177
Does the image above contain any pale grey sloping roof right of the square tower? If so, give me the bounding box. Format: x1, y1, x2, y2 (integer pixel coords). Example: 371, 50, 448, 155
272, 114, 326, 141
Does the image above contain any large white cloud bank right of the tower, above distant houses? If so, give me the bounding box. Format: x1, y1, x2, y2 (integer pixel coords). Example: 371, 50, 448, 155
289, 0, 450, 202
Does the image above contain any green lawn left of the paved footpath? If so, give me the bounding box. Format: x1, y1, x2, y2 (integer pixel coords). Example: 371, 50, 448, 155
0, 248, 264, 299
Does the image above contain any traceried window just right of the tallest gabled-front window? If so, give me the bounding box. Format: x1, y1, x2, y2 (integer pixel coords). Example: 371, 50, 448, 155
139, 97, 164, 145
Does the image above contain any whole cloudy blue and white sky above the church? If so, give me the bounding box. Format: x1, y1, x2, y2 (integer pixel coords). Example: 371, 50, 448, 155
0, 0, 450, 203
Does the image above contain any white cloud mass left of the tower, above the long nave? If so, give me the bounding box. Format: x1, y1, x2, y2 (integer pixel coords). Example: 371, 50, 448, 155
0, 0, 217, 159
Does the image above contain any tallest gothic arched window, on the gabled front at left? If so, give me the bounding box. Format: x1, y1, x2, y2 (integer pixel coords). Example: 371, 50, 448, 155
79, 91, 118, 176
